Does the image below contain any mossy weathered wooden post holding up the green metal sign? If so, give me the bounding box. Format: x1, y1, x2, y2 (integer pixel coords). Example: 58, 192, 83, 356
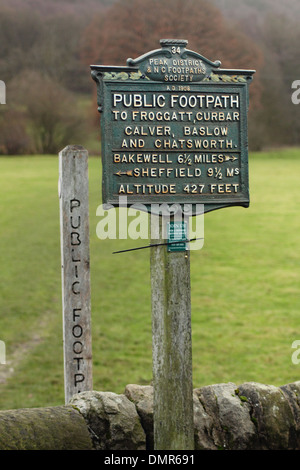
150, 216, 194, 450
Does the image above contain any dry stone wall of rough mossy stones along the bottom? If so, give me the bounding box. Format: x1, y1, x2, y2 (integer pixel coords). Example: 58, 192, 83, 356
0, 381, 300, 450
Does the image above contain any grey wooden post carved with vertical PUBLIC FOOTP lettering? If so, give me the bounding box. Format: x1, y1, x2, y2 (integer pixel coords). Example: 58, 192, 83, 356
59, 145, 93, 404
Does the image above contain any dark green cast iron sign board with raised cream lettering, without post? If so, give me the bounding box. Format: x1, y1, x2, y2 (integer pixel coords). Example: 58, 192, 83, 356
91, 40, 254, 212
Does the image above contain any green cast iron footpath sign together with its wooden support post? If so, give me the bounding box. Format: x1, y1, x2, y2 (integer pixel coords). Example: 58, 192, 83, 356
91, 39, 254, 450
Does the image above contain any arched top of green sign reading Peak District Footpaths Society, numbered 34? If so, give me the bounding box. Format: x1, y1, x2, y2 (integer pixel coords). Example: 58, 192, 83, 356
127, 39, 221, 82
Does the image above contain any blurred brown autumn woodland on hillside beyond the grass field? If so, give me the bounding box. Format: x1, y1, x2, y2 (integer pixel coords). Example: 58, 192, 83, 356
0, 0, 300, 155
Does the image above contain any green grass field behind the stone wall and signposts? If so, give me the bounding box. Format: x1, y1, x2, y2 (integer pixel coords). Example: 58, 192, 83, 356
0, 149, 300, 409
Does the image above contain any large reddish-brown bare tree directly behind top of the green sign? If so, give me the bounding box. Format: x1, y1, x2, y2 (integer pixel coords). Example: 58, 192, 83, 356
81, 0, 263, 138
